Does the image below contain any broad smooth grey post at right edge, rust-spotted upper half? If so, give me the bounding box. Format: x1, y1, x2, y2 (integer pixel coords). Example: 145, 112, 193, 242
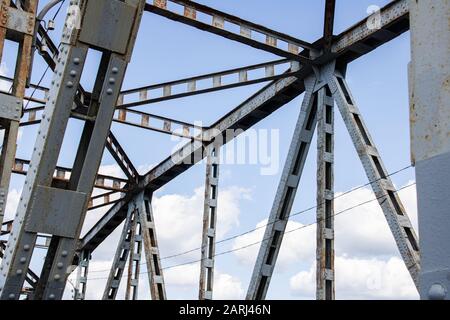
408, 0, 450, 300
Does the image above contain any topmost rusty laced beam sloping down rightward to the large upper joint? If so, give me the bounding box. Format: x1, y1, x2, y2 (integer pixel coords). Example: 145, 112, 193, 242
145, 0, 312, 64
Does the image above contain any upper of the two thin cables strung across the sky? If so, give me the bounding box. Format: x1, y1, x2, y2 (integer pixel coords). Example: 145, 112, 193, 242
86, 165, 412, 273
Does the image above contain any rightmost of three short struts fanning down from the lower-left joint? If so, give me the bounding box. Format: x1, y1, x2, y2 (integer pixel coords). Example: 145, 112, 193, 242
135, 191, 167, 300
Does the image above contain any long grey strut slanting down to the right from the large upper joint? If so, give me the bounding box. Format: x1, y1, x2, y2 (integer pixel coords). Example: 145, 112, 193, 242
326, 64, 420, 287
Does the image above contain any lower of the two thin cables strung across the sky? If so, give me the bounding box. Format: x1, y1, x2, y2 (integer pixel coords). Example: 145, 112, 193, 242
88, 182, 416, 280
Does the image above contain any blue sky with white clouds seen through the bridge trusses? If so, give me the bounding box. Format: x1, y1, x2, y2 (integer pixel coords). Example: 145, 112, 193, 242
1, 0, 415, 299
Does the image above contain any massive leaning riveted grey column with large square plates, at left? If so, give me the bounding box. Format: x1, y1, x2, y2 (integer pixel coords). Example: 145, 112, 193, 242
0, 0, 145, 300
